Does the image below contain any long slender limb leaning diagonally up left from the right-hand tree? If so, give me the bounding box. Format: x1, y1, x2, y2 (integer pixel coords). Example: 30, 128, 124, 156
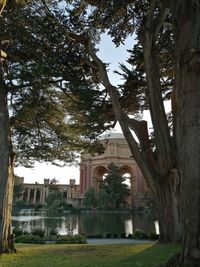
41, 0, 156, 192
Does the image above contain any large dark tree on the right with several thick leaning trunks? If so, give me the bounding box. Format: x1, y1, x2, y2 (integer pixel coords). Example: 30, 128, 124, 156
39, 0, 200, 267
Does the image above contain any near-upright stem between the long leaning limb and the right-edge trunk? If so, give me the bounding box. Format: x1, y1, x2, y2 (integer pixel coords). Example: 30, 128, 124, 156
142, 2, 175, 177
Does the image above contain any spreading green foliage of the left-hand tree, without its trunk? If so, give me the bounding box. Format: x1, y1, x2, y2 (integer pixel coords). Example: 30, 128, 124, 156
0, 1, 113, 170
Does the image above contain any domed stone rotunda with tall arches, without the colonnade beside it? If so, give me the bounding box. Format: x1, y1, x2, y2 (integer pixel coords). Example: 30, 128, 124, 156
80, 133, 147, 207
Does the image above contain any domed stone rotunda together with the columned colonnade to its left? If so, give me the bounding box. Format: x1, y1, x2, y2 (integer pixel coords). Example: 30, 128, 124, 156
16, 133, 148, 207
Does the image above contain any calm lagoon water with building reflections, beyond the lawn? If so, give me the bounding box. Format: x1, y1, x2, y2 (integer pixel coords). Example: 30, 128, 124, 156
13, 210, 155, 236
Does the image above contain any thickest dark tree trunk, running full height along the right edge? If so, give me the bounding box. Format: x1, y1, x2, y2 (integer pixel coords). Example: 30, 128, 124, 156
172, 0, 200, 267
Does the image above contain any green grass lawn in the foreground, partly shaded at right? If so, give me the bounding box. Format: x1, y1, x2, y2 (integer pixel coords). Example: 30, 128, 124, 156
0, 243, 180, 267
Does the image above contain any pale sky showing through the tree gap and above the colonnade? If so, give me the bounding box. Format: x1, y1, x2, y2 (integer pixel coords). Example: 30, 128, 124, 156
15, 34, 134, 184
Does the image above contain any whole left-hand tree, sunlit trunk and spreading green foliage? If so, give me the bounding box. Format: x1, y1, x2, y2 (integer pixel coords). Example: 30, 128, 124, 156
0, 1, 110, 253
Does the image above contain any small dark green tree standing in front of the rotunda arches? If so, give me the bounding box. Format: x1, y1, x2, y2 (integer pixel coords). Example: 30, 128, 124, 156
99, 163, 130, 208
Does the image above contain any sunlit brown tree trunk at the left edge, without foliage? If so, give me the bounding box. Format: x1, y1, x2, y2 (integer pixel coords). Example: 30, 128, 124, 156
0, 79, 15, 253
